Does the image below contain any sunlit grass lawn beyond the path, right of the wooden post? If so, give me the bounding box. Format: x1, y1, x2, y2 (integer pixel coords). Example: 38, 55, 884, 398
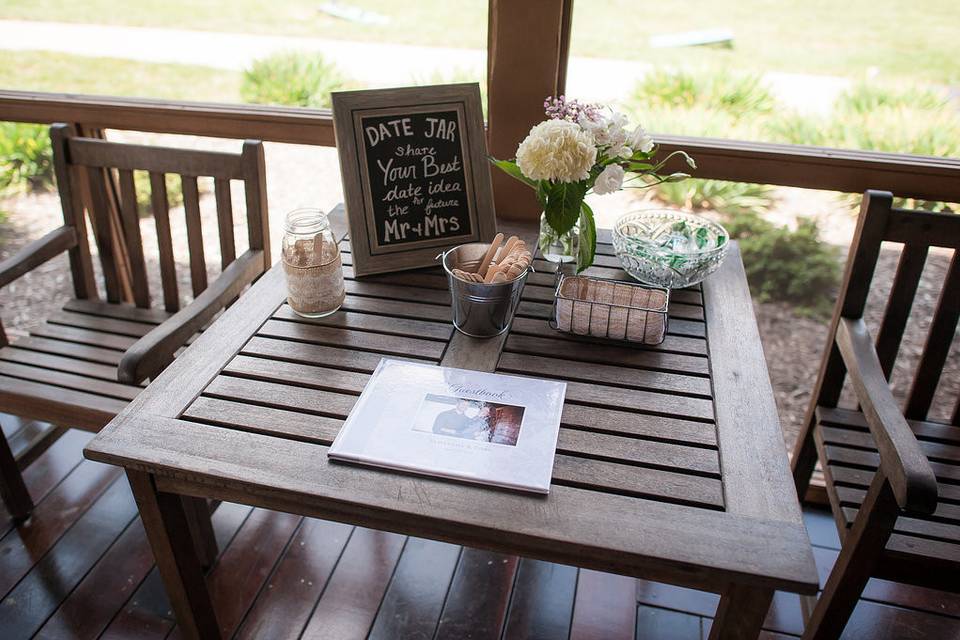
572, 0, 960, 84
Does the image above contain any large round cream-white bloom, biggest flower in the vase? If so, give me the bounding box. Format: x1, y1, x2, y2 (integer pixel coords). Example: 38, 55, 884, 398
517, 120, 597, 182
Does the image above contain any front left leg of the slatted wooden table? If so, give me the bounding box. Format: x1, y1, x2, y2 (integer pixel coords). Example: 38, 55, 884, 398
127, 469, 221, 640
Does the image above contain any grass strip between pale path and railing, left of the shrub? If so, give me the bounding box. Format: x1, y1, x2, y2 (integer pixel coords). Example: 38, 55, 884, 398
0, 51, 241, 102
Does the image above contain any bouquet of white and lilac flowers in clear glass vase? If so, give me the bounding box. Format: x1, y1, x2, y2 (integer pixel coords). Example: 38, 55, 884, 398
490, 96, 696, 272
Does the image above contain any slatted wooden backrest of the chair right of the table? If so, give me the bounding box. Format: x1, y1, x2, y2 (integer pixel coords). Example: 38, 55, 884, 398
818, 191, 960, 425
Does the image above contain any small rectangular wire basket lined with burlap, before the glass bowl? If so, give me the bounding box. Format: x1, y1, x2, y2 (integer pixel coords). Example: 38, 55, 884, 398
550, 274, 670, 345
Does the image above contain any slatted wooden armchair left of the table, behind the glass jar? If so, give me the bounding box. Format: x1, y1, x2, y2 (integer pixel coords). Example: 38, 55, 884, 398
0, 124, 270, 518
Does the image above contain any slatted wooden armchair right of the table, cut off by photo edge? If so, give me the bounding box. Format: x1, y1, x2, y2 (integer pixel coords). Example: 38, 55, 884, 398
793, 191, 960, 638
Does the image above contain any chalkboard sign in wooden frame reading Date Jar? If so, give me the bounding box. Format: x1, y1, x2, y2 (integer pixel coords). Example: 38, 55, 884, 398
333, 84, 496, 275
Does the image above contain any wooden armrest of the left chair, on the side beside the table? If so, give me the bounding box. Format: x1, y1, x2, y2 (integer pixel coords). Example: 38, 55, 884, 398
117, 250, 264, 384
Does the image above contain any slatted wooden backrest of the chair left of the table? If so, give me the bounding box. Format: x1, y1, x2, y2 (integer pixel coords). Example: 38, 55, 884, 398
51, 124, 270, 312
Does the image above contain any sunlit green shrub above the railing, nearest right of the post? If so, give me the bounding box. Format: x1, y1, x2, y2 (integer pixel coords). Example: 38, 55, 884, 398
628, 69, 776, 119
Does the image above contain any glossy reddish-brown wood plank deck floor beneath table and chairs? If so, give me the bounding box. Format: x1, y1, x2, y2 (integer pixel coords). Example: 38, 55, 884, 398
0, 415, 960, 640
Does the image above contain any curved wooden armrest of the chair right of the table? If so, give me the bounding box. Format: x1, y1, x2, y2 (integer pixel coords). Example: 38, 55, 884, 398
837, 318, 937, 513
